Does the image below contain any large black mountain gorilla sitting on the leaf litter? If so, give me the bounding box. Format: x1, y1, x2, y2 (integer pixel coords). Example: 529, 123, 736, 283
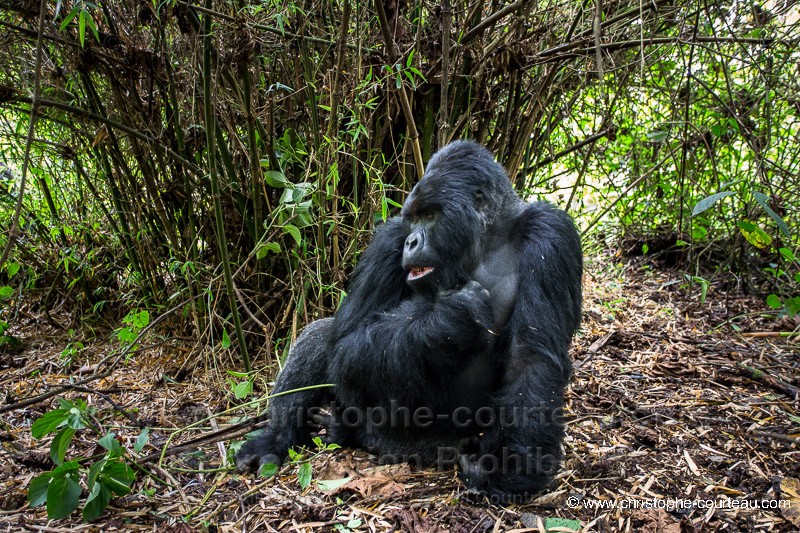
236, 141, 583, 498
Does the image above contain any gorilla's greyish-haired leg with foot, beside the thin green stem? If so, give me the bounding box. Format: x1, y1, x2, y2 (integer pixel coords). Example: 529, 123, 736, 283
236, 318, 333, 471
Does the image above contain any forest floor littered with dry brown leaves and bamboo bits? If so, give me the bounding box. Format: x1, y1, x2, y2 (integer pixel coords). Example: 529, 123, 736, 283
0, 252, 800, 533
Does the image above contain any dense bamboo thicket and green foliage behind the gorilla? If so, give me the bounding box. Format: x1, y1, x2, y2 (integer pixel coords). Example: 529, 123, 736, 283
0, 0, 800, 369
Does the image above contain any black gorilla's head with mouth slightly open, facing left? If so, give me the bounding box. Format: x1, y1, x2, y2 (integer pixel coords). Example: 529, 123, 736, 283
401, 141, 521, 294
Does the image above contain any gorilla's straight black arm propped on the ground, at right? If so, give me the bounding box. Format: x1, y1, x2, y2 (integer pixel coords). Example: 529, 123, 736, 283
461, 203, 583, 494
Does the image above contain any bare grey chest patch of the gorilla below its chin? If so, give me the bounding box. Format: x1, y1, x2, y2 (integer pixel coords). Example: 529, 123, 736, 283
472, 243, 519, 328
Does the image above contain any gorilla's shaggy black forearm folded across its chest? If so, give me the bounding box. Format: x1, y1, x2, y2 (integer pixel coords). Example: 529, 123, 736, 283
331, 282, 493, 407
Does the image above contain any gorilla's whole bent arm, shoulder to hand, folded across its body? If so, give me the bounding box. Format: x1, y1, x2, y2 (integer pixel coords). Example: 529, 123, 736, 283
330, 218, 492, 407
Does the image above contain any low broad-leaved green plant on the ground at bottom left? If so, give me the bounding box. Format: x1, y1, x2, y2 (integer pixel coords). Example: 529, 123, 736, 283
28, 398, 138, 522
